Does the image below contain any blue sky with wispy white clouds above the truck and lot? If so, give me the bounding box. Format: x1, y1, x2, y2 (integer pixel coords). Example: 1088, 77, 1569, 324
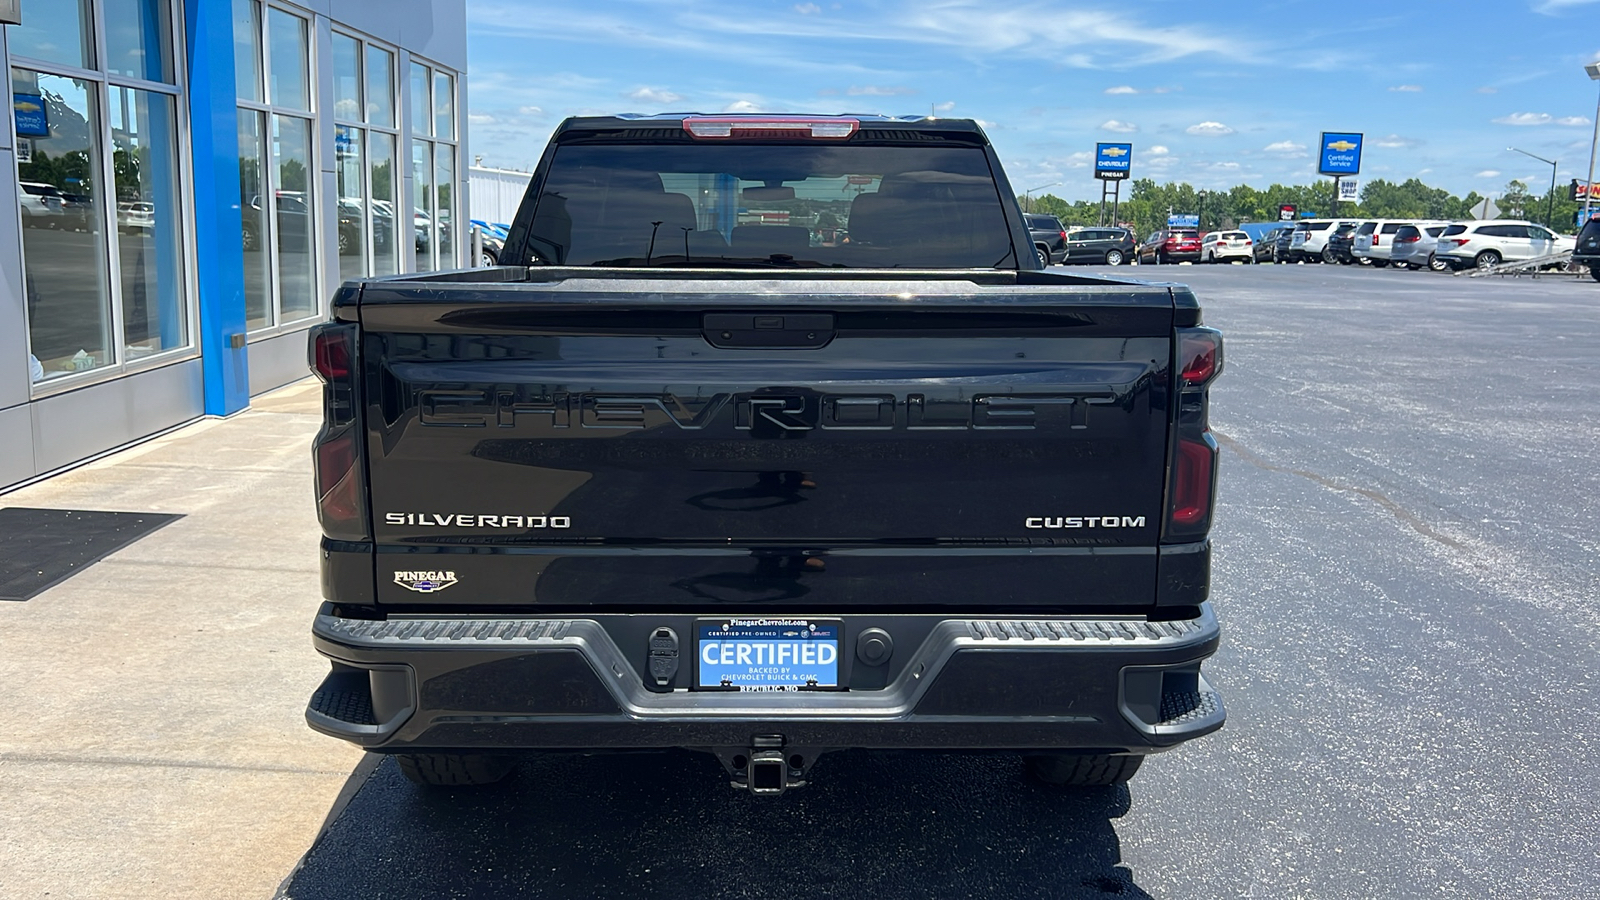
467, 0, 1600, 200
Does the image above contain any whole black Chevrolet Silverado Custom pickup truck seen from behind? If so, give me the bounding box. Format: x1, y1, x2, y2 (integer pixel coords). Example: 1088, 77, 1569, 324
306, 115, 1224, 794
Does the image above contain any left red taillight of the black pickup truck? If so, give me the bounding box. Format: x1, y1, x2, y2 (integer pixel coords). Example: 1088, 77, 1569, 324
310, 322, 370, 541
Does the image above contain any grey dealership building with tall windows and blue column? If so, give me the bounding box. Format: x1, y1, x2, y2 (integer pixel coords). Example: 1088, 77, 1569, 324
0, 0, 469, 490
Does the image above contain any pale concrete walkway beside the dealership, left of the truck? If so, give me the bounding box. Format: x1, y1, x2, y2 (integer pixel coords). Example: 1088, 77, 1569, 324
0, 381, 362, 900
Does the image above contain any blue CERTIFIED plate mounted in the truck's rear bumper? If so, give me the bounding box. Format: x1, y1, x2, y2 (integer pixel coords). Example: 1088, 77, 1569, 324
694, 618, 840, 692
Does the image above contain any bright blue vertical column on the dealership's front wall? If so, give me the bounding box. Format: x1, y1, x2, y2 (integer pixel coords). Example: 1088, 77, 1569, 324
184, 0, 250, 416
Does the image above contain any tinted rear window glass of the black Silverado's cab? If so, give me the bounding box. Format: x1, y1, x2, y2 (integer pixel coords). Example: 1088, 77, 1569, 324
530, 143, 1017, 269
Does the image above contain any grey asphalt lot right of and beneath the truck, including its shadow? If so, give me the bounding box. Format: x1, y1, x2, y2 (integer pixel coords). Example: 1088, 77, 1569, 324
268, 266, 1600, 900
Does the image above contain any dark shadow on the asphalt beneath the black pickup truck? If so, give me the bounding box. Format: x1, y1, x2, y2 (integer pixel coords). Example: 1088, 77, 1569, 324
280, 751, 1150, 900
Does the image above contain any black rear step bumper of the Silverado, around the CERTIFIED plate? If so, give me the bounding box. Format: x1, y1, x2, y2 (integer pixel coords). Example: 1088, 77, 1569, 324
306, 605, 1226, 754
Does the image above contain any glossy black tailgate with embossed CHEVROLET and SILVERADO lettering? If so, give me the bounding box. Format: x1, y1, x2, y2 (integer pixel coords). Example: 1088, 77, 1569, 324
360, 272, 1173, 612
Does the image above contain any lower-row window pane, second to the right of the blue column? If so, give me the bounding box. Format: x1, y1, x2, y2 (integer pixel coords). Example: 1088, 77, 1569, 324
272, 115, 318, 323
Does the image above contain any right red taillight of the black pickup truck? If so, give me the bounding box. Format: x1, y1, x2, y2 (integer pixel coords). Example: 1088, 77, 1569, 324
1162, 328, 1222, 543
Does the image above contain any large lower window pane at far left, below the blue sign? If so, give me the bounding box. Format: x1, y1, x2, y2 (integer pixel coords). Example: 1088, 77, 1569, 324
11, 69, 115, 381
